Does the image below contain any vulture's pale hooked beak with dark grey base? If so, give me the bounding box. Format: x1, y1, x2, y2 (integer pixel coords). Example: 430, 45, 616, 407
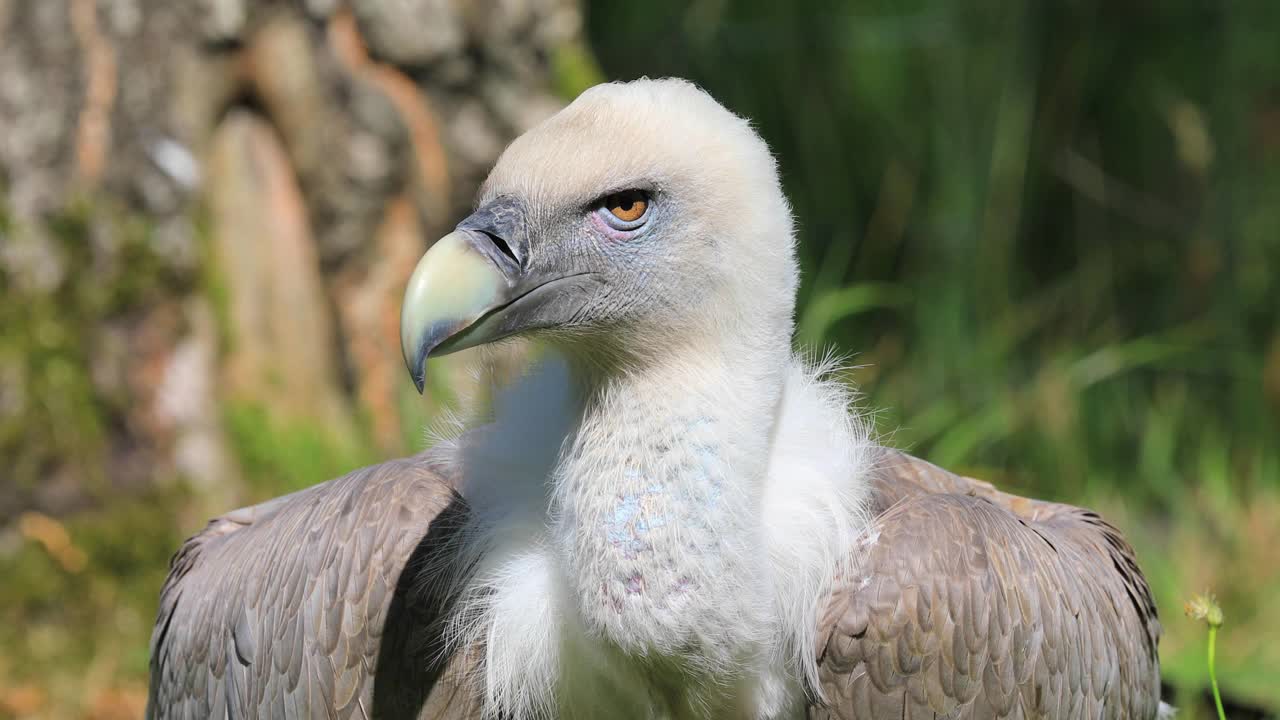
401, 200, 595, 393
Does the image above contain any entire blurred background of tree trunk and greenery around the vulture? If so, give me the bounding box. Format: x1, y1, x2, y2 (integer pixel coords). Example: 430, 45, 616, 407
0, 0, 1280, 719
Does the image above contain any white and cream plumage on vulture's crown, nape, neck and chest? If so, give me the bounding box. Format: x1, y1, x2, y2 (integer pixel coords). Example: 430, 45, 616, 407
435, 81, 869, 717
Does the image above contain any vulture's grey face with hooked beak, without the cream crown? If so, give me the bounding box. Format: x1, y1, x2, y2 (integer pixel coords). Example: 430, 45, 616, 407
401, 167, 723, 392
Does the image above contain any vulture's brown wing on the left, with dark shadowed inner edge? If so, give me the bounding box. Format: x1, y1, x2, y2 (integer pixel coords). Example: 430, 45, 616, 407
147, 455, 477, 719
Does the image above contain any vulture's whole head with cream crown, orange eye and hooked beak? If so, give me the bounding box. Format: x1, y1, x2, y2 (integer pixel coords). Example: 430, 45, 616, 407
401, 79, 797, 392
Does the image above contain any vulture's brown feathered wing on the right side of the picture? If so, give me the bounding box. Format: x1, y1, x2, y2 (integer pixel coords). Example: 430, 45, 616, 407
810, 451, 1160, 719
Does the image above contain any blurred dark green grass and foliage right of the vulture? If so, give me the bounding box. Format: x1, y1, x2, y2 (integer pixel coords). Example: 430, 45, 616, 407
588, 0, 1280, 714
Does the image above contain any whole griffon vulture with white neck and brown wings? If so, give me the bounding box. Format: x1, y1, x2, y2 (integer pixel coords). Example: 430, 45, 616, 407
148, 79, 1160, 719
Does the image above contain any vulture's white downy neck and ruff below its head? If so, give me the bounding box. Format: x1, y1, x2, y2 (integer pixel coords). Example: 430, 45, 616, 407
440, 326, 865, 717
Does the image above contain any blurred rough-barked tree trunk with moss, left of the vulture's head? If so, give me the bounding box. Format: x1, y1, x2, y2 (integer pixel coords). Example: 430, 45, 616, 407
0, 0, 579, 517
